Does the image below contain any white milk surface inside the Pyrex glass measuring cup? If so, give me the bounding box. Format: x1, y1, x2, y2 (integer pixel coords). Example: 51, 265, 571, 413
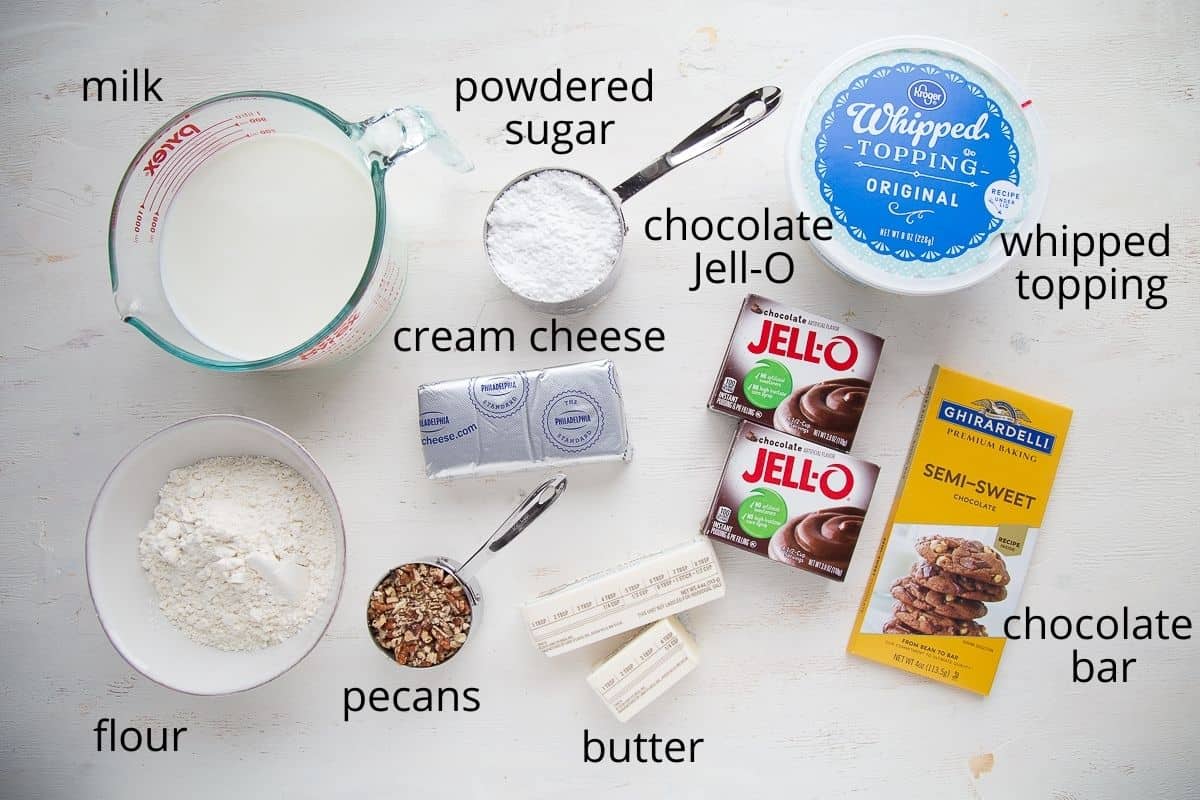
160, 134, 376, 361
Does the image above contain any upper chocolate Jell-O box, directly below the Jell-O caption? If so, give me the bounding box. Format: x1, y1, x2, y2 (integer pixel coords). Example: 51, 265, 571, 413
708, 295, 883, 452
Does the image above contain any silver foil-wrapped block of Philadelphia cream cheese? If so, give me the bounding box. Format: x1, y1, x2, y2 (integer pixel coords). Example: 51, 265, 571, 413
416, 361, 632, 477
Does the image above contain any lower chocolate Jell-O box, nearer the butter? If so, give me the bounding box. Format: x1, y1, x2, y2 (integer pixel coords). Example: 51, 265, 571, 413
704, 422, 880, 581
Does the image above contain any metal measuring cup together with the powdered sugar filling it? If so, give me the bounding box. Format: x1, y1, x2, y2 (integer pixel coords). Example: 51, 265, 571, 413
484, 86, 782, 314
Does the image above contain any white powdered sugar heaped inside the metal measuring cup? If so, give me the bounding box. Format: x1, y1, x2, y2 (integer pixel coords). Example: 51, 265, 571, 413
486, 169, 624, 302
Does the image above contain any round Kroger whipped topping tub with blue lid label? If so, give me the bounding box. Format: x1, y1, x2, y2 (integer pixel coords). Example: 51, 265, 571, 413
787, 36, 1046, 295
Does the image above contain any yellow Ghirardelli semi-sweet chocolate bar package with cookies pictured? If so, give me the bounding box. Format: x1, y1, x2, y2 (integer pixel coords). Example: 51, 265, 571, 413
846, 367, 1070, 694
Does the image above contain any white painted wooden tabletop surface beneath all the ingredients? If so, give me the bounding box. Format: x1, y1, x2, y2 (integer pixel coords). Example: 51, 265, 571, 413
0, 0, 1200, 800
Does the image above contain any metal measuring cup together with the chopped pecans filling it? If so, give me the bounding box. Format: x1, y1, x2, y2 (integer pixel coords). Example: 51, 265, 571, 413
367, 475, 566, 668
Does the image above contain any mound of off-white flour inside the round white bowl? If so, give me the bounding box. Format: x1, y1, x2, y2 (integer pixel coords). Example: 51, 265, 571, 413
138, 456, 336, 650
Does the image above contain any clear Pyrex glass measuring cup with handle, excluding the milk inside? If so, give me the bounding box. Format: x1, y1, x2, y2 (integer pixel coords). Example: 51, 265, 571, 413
108, 91, 472, 372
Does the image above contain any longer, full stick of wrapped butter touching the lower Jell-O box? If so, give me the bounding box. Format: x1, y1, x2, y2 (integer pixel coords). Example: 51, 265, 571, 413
521, 537, 725, 656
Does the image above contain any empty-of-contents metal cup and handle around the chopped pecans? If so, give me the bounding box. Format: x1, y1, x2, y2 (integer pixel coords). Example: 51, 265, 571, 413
367, 474, 566, 669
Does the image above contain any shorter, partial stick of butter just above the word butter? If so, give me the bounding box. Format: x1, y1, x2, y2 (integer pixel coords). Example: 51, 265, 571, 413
588, 616, 700, 722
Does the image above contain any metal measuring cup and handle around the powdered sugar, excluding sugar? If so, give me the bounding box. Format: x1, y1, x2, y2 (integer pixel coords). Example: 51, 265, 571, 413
484, 86, 782, 314
